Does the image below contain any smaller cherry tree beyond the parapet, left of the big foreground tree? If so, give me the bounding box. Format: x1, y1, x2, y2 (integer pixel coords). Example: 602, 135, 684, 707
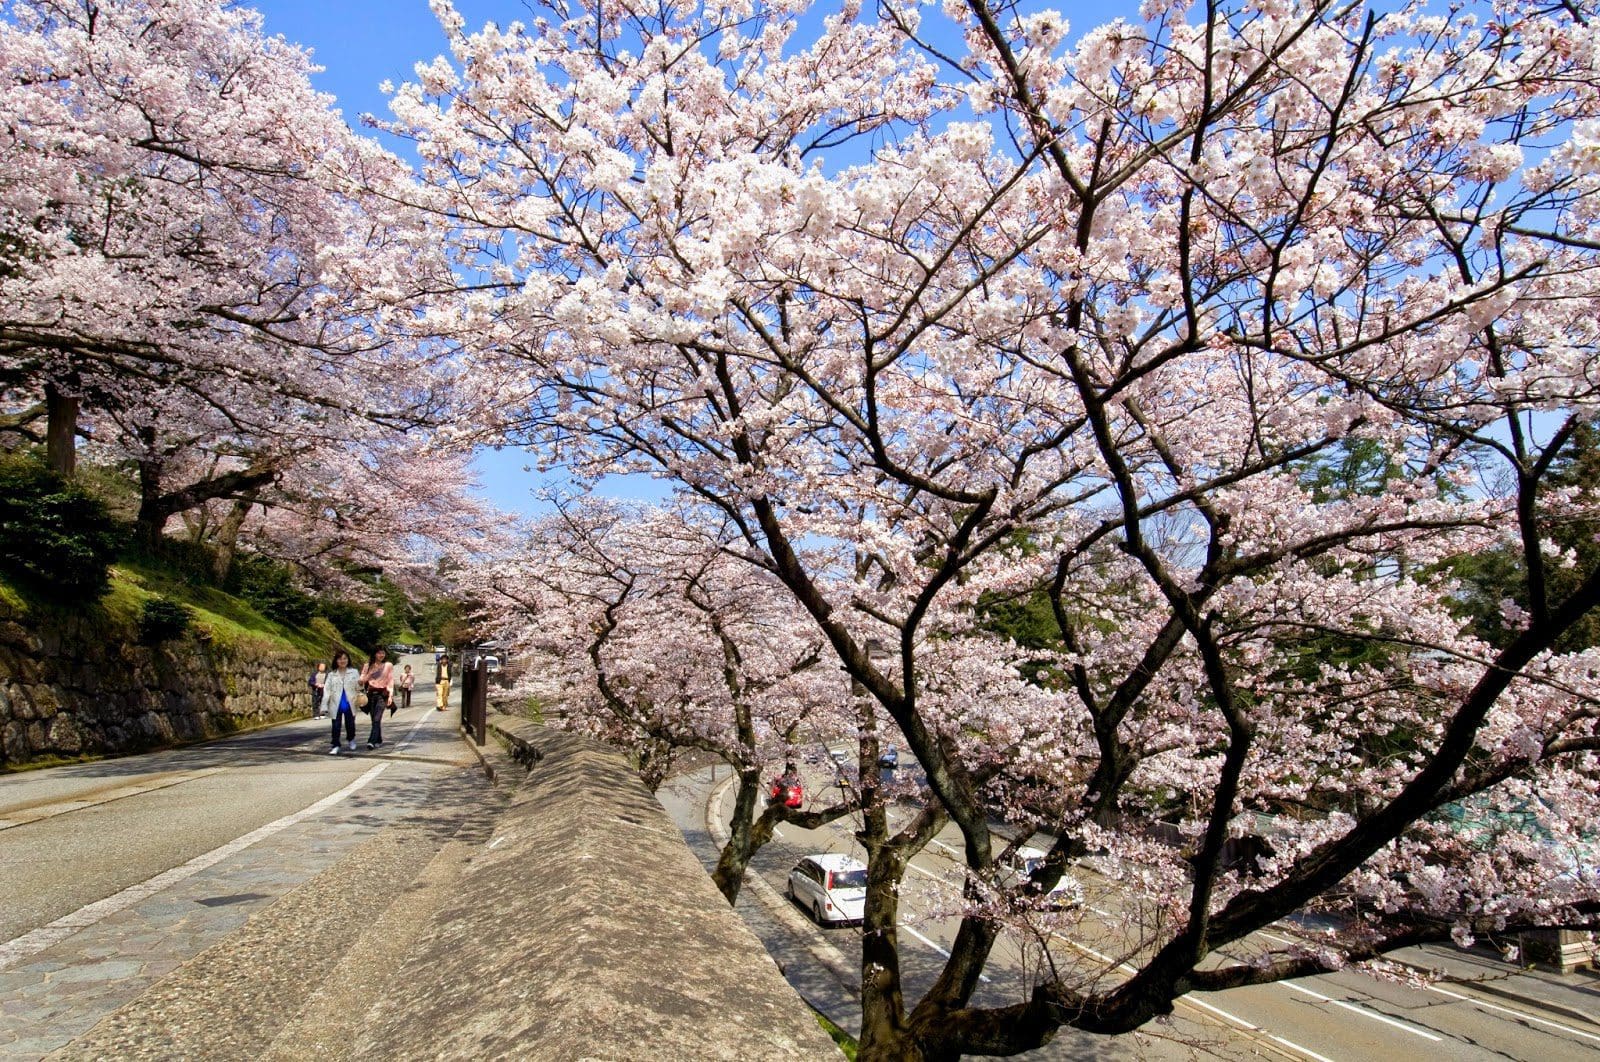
462, 499, 859, 904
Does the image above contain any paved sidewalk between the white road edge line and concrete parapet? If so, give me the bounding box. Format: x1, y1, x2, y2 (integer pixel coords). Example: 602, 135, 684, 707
0, 697, 496, 1060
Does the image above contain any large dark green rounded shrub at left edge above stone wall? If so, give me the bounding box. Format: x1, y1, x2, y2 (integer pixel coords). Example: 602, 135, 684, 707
0, 453, 128, 603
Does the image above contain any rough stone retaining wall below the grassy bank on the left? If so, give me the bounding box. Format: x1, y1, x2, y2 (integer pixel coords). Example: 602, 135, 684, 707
0, 614, 310, 769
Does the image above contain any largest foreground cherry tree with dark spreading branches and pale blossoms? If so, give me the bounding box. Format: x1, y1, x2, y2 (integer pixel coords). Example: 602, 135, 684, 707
394, 0, 1600, 1059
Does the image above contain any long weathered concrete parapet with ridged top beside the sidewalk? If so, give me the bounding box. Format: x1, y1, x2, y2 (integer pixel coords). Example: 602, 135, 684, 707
354, 723, 840, 1062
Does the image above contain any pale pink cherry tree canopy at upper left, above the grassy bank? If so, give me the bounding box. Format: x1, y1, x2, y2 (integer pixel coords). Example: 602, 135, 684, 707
0, 0, 451, 470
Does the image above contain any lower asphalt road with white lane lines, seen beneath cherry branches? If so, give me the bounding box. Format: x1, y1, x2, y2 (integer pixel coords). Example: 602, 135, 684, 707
678, 754, 1600, 1062
